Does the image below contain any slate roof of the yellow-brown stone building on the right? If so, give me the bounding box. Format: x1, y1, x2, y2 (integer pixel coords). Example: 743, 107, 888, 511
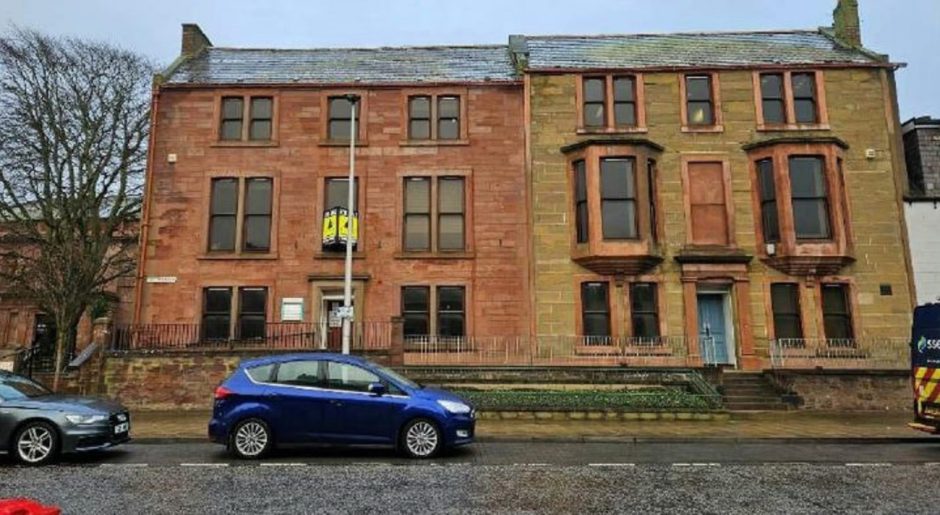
523, 30, 880, 70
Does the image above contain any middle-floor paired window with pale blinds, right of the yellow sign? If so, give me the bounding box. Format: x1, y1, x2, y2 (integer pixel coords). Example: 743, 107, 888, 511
402, 177, 466, 252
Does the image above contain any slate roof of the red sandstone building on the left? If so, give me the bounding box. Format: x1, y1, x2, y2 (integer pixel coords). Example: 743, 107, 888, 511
165, 45, 518, 84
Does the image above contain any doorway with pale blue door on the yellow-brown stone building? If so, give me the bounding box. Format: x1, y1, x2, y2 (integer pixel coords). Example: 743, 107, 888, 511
696, 288, 736, 365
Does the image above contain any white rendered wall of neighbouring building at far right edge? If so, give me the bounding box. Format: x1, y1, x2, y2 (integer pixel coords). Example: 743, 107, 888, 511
904, 200, 940, 306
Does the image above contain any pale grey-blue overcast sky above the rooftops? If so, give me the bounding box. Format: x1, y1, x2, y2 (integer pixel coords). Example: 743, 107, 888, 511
0, 0, 940, 121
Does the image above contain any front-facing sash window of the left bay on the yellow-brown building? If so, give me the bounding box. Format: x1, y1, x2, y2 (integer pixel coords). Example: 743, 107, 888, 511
601, 158, 637, 240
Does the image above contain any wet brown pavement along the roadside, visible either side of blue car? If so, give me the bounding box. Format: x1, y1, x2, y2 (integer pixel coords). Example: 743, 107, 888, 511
131, 411, 925, 442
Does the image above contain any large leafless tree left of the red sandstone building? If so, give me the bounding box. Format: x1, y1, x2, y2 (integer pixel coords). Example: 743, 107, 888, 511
0, 29, 154, 389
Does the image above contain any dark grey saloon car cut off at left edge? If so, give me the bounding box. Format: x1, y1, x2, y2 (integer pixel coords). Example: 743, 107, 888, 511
0, 371, 131, 465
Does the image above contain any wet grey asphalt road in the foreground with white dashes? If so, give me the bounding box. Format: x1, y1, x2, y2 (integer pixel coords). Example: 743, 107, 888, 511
0, 441, 940, 514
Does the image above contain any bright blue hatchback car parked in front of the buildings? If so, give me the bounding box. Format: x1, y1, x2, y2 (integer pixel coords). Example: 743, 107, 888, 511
209, 353, 476, 459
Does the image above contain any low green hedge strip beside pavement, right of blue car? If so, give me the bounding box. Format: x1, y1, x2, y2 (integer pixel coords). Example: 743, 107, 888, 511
456, 389, 718, 411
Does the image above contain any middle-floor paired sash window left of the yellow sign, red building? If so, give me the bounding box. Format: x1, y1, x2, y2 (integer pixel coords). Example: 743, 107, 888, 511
209, 177, 274, 252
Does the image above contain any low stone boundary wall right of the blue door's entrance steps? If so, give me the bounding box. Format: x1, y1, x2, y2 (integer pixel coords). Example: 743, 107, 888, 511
767, 370, 914, 412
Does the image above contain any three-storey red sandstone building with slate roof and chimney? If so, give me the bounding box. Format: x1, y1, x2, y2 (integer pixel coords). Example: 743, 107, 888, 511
134, 25, 529, 348
